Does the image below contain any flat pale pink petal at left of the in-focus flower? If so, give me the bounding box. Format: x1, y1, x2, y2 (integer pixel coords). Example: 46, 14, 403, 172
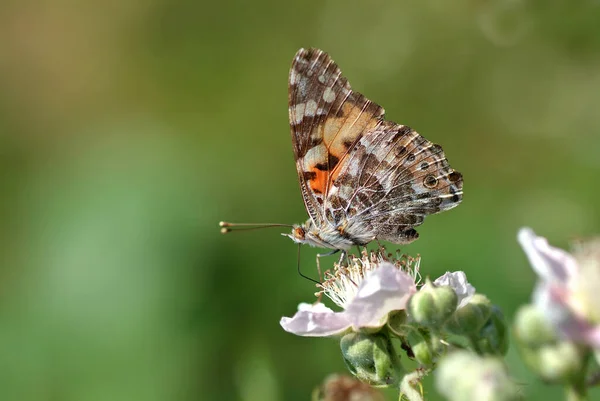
279, 303, 350, 337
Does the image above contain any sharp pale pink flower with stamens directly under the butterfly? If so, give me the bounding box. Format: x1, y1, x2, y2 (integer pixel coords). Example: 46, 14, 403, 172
280, 253, 474, 337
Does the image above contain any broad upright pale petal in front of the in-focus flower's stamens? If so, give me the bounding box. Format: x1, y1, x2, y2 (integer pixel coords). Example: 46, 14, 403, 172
346, 262, 417, 329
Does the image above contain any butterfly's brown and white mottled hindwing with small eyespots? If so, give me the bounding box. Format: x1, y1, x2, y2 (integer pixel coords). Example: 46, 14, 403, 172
327, 121, 463, 244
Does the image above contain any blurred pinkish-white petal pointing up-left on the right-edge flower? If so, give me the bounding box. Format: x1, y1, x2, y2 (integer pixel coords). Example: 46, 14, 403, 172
518, 228, 577, 283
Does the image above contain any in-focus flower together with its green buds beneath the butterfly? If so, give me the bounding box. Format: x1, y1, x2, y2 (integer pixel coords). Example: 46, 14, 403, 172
280, 248, 508, 398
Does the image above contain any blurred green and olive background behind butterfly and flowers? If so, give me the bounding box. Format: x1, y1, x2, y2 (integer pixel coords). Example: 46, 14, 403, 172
0, 0, 600, 401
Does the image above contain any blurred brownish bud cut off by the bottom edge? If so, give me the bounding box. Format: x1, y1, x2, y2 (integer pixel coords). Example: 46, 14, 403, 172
312, 375, 384, 401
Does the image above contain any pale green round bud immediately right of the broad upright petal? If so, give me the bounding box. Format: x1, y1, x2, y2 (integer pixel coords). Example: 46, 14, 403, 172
408, 279, 458, 330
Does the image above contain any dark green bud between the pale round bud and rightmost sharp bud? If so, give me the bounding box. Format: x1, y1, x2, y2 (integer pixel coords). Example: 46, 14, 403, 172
445, 294, 492, 336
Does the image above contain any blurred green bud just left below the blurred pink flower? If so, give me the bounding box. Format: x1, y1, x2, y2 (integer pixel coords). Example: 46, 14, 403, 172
513, 304, 557, 348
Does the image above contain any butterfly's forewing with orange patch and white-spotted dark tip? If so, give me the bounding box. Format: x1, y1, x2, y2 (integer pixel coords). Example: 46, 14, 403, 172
288, 49, 384, 227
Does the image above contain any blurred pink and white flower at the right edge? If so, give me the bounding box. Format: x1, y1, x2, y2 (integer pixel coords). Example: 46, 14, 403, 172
518, 228, 600, 348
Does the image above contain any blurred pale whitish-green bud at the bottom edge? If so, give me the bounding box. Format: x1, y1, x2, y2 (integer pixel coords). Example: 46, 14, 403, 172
435, 351, 523, 401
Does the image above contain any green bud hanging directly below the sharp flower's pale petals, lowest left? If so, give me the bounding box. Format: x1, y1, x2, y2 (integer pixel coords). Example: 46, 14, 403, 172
340, 332, 403, 387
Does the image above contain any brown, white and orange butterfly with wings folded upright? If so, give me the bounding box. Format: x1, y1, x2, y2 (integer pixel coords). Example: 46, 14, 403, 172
288, 49, 463, 250
